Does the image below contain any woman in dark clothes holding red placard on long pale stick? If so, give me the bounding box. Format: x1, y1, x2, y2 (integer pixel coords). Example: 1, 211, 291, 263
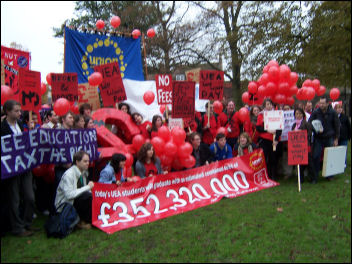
292, 108, 317, 184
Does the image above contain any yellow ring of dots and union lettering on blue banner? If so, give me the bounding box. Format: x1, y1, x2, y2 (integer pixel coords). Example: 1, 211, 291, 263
81, 38, 127, 78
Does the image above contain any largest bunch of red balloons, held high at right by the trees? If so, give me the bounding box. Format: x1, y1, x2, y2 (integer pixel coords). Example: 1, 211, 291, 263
242, 60, 298, 105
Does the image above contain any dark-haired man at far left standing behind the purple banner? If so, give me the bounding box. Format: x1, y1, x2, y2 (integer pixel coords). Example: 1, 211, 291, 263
1, 100, 35, 237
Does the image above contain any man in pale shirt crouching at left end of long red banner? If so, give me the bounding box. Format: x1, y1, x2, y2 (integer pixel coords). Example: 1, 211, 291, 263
55, 150, 94, 229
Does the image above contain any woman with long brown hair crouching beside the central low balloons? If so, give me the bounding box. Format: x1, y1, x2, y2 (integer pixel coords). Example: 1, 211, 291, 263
136, 143, 168, 178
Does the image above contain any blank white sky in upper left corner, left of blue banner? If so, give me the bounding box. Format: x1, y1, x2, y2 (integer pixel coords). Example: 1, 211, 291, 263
1, 1, 75, 83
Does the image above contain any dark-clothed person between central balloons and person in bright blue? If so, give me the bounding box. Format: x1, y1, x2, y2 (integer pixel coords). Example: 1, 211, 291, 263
190, 132, 214, 168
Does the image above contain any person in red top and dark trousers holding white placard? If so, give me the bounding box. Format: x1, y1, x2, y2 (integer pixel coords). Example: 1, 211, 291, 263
257, 98, 282, 180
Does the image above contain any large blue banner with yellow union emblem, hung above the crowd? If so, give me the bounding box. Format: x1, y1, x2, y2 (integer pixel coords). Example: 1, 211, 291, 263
65, 27, 144, 83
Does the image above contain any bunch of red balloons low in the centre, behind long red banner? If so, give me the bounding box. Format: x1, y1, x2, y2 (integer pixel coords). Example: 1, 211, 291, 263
132, 126, 196, 171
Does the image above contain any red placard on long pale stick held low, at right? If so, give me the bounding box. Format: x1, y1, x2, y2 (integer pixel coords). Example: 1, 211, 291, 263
287, 130, 308, 165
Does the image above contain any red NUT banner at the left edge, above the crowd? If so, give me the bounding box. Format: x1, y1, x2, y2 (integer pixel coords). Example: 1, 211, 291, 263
1, 46, 31, 101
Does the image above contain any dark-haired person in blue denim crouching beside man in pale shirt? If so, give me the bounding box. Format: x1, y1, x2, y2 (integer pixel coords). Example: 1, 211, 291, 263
99, 153, 132, 185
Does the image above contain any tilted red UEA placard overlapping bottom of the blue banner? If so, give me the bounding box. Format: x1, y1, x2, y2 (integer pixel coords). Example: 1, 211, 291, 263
94, 62, 127, 107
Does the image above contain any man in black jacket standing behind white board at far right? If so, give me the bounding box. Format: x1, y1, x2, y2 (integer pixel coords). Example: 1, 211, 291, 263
309, 96, 340, 183
